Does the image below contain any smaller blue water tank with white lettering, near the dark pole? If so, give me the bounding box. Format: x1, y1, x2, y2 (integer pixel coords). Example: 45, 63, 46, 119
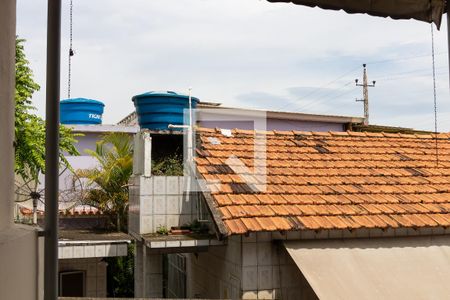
59, 98, 105, 125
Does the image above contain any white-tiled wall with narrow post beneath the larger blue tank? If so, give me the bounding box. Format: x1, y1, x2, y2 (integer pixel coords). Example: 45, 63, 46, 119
128, 131, 199, 239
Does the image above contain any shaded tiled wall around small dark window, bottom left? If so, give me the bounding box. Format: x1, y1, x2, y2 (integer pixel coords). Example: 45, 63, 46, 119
59, 258, 107, 297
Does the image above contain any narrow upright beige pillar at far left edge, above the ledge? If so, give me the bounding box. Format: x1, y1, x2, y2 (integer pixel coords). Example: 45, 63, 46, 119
0, 0, 16, 231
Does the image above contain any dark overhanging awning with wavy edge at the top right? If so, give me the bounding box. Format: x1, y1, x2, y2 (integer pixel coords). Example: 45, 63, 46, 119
268, 0, 445, 28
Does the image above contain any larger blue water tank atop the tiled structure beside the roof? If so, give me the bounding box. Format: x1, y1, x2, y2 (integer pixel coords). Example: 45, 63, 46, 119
132, 91, 199, 130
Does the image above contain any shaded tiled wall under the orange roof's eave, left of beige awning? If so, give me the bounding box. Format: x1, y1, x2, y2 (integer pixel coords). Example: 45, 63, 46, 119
186, 233, 317, 300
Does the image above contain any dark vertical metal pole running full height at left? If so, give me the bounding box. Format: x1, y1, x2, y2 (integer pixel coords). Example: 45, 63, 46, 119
44, 0, 61, 300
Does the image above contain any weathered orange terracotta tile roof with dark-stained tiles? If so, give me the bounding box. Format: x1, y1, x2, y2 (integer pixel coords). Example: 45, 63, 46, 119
196, 129, 450, 234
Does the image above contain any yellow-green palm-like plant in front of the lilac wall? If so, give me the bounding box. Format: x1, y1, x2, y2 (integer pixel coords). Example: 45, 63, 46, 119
78, 133, 133, 232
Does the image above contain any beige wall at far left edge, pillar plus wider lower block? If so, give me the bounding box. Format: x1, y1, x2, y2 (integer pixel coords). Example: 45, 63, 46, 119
0, 0, 42, 300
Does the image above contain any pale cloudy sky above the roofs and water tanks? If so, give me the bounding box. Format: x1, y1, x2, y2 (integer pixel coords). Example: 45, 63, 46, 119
17, 0, 450, 131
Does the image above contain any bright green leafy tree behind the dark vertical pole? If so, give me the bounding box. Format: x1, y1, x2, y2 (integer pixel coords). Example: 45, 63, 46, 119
14, 38, 79, 181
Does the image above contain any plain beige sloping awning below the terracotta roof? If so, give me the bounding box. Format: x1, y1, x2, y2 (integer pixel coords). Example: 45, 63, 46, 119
284, 236, 450, 300
